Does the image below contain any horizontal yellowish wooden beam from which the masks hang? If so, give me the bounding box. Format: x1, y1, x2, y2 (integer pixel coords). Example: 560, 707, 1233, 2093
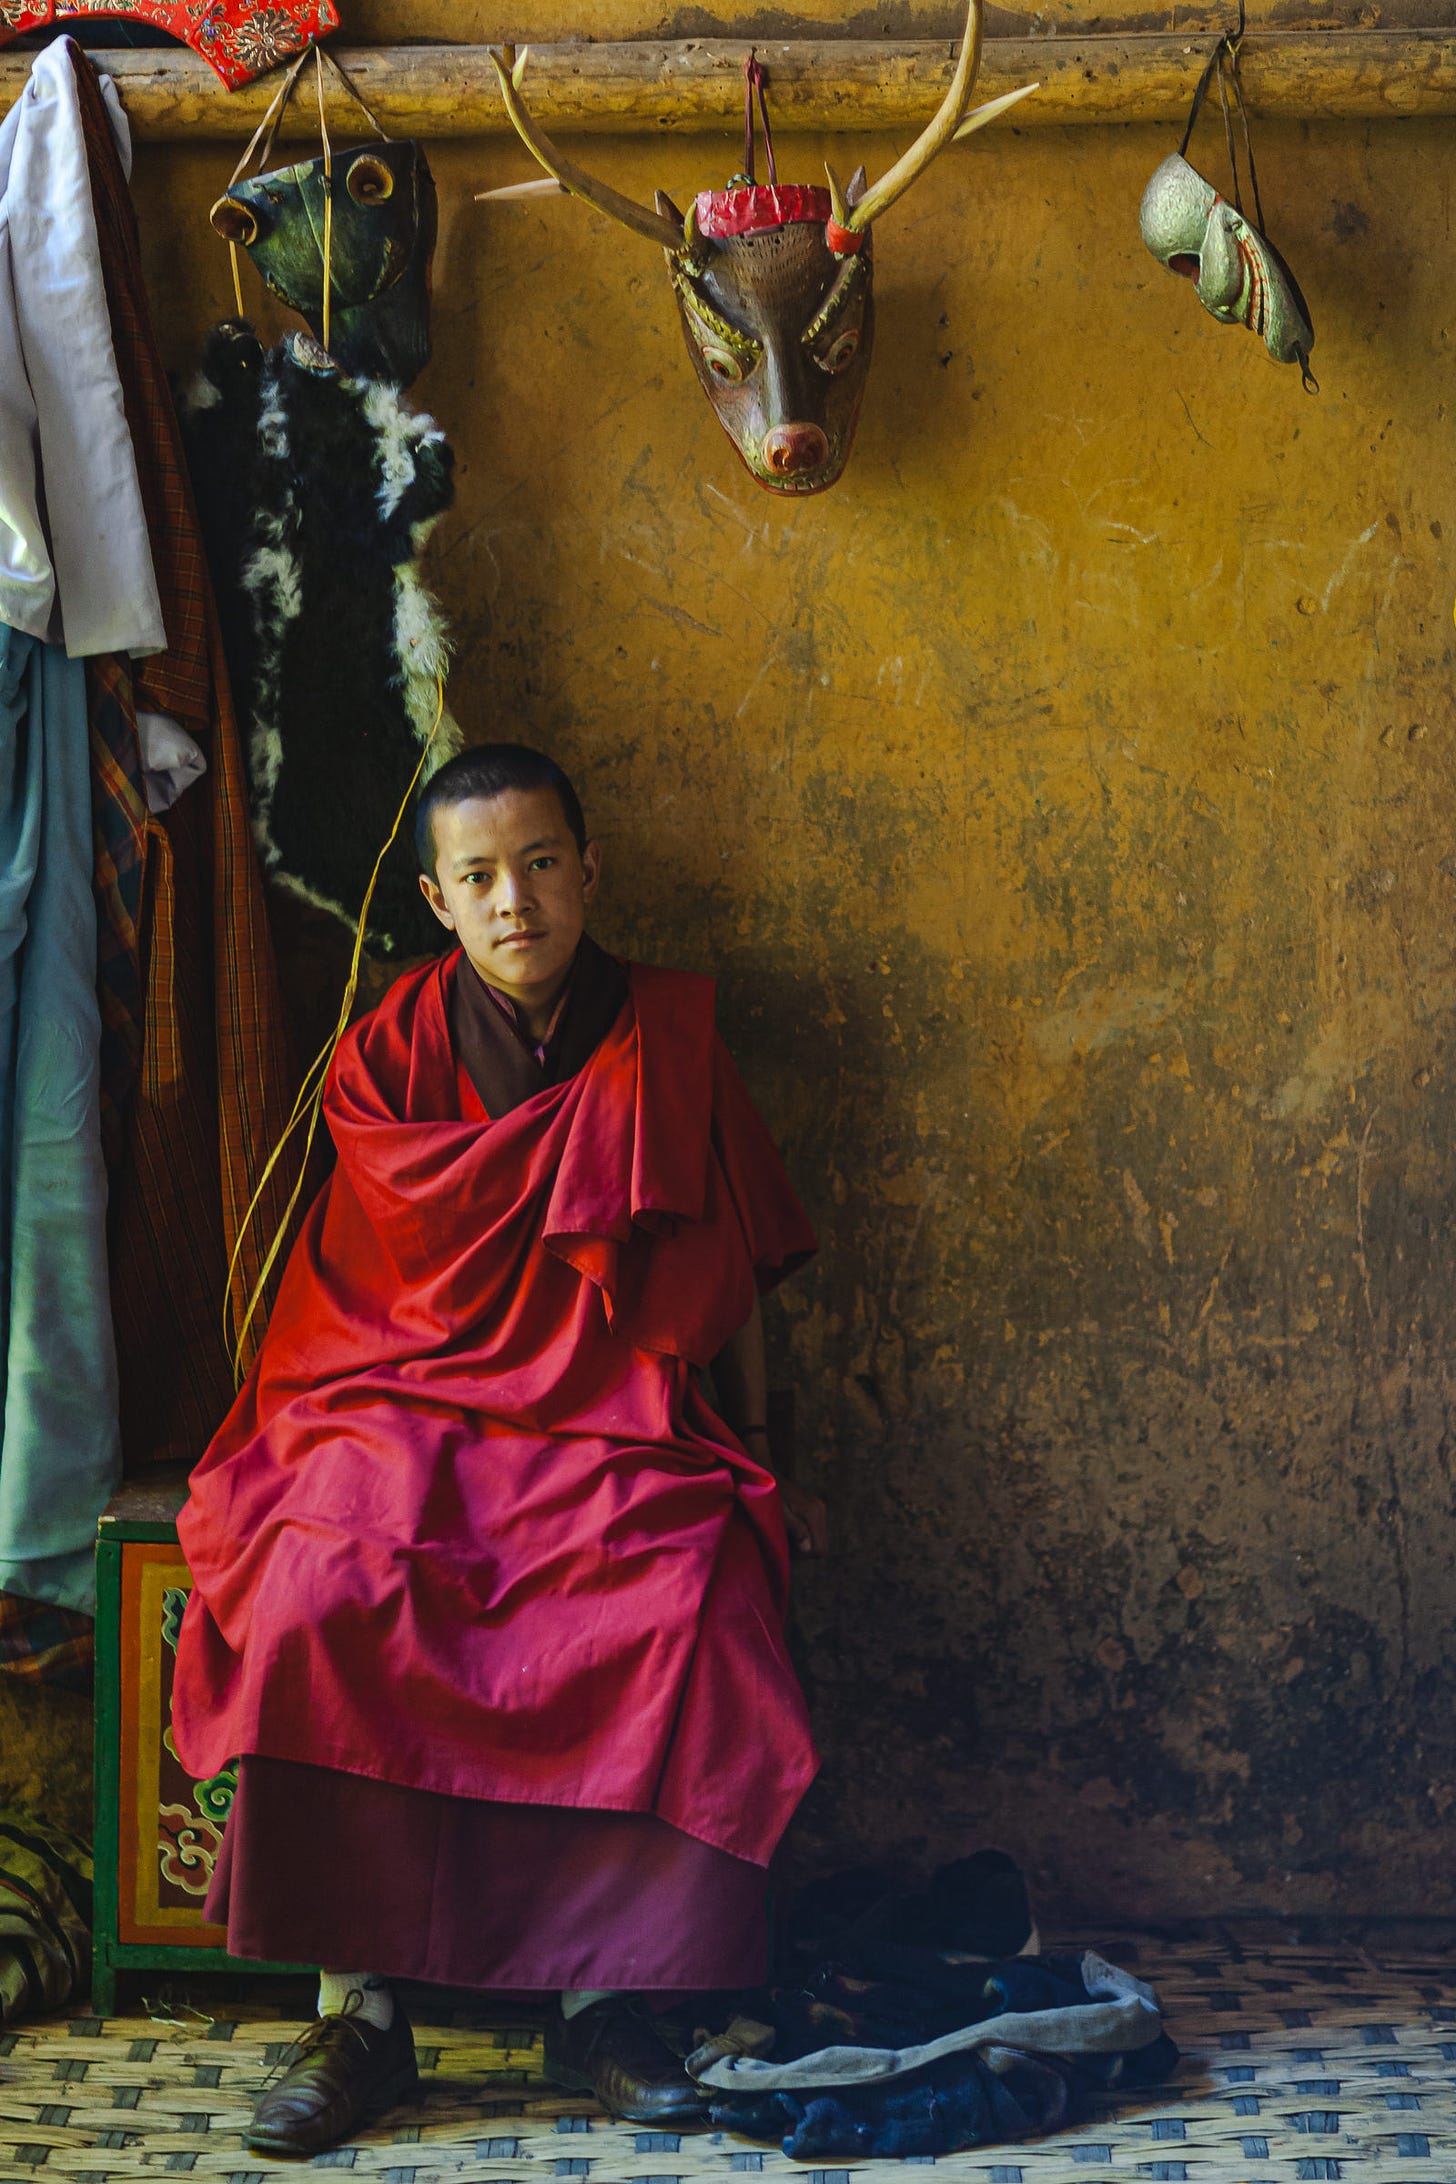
0, 31, 1456, 142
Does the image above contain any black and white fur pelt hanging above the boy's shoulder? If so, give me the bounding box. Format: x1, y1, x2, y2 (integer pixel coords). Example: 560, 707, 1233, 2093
183, 321, 461, 954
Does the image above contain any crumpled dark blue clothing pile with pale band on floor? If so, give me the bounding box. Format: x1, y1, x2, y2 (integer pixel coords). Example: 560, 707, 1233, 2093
688, 1852, 1179, 2160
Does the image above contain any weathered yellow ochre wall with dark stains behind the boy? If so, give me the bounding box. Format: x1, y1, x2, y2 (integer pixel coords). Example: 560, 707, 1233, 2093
125, 59, 1456, 1918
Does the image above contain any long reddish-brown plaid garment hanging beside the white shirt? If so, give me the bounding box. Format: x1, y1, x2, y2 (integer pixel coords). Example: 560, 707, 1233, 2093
72, 48, 293, 1468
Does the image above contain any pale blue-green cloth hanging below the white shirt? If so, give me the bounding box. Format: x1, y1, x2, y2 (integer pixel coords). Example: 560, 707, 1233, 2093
0, 625, 120, 1612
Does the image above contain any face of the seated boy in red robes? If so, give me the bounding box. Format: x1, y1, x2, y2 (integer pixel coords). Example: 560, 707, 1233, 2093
419, 788, 600, 1007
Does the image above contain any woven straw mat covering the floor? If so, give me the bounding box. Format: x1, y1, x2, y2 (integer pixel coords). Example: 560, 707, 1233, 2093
0, 1928, 1456, 2184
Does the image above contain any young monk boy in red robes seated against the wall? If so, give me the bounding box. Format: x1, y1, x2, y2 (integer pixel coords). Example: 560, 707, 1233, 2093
172, 743, 823, 2153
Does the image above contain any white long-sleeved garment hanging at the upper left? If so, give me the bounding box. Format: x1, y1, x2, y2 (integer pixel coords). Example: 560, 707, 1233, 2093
0, 39, 166, 660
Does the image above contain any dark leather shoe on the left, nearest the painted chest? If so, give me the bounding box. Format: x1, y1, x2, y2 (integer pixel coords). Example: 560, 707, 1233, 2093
242, 2003, 419, 2153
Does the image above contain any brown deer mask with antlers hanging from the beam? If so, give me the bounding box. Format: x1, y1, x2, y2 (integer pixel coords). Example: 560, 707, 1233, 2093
482, 0, 1037, 494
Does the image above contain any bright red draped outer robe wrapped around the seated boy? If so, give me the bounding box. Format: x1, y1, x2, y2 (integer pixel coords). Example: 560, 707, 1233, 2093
172, 957, 814, 1865
